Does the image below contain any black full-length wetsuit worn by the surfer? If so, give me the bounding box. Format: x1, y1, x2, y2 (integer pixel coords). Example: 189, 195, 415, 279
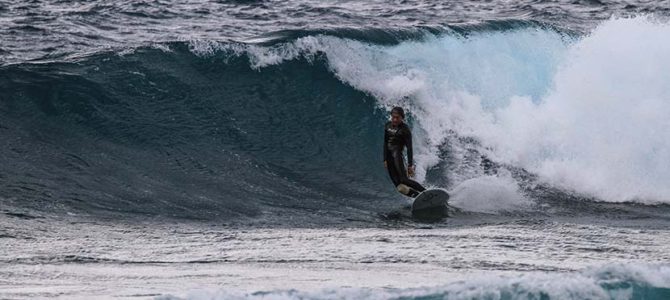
384, 121, 426, 197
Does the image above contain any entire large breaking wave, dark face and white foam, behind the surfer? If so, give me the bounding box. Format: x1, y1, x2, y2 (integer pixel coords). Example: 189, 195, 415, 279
0, 18, 670, 220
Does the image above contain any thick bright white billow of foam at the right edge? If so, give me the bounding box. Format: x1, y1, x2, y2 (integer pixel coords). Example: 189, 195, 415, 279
486, 18, 670, 202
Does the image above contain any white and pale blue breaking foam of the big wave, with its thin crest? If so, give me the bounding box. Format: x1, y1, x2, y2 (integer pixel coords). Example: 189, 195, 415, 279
200, 17, 670, 203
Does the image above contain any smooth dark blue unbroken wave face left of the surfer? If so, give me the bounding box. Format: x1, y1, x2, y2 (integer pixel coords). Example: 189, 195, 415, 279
0, 43, 393, 218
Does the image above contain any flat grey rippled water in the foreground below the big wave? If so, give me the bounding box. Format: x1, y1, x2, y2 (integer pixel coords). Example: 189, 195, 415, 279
0, 214, 670, 299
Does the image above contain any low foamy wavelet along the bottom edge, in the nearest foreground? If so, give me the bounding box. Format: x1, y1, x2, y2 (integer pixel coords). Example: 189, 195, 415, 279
160, 263, 670, 300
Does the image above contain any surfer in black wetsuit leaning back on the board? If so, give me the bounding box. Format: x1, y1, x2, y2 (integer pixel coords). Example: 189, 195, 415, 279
384, 106, 426, 197
